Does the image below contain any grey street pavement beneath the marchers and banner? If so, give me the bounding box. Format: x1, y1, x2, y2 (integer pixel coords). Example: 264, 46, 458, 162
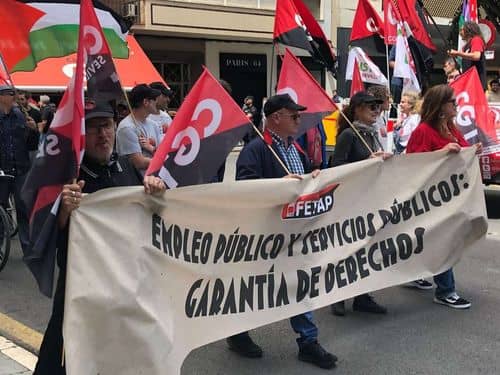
0, 153, 500, 375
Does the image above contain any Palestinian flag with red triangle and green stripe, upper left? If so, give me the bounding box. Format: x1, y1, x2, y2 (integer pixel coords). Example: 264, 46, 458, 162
0, 0, 130, 72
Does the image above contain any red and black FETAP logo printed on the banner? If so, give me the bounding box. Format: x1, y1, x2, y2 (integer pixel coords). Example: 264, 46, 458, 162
281, 184, 339, 220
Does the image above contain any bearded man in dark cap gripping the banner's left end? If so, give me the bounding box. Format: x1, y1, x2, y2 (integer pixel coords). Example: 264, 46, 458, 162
34, 100, 166, 375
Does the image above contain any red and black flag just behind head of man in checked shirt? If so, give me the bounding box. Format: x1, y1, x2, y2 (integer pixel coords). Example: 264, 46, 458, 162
277, 48, 336, 136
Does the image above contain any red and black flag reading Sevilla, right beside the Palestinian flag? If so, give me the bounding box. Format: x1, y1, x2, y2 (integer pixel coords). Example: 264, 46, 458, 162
81, 1, 123, 101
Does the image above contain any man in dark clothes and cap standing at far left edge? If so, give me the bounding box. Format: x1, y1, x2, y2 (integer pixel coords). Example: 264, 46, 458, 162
0, 84, 38, 250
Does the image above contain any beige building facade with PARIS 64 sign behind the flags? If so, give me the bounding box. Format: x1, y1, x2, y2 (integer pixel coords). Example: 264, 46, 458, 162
101, 0, 500, 103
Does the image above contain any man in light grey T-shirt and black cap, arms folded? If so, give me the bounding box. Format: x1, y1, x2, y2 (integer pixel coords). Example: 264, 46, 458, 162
116, 84, 163, 174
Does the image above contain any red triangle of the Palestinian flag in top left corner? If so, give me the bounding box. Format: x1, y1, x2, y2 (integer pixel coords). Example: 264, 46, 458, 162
0, 0, 45, 71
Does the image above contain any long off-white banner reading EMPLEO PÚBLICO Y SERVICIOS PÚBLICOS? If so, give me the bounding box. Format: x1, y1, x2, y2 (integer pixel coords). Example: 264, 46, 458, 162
64, 149, 487, 375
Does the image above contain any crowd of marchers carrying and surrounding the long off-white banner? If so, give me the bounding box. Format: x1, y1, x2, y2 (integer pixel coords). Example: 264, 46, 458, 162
0, 17, 500, 374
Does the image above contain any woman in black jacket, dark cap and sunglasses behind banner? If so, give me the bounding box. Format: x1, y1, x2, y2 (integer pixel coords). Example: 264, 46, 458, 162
330, 91, 388, 316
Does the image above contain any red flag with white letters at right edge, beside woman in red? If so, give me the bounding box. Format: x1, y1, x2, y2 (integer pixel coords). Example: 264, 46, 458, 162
450, 68, 500, 154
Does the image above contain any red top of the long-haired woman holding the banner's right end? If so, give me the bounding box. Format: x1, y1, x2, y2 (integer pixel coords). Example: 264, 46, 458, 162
406, 122, 469, 153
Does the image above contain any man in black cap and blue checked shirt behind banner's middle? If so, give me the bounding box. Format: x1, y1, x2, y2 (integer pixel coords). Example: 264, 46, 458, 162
227, 94, 337, 369
